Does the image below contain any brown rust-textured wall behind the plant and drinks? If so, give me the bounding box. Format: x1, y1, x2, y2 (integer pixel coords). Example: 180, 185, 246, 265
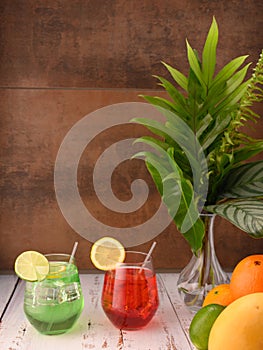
0, 0, 263, 270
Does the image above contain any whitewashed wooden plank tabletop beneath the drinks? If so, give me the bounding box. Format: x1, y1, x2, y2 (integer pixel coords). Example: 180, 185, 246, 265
0, 273, 195, 350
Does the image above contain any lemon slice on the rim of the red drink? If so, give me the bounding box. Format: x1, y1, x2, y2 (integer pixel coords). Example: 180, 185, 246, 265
90, 237, 125, 271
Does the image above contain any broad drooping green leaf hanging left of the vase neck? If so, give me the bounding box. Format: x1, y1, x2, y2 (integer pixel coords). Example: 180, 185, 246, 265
133, 140, 204, 253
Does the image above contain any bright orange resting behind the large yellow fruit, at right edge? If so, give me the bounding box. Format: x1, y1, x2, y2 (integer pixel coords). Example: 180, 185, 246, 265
230, 254, 263, 300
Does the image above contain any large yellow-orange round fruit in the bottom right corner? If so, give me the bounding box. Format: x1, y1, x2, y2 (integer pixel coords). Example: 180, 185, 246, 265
208, 293, 263, 350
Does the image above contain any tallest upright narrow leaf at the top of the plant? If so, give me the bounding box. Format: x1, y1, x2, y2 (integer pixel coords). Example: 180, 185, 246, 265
202, 17, 218, 88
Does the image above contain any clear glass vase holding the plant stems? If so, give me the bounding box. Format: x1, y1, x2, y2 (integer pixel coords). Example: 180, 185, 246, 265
177, 214, 229, 312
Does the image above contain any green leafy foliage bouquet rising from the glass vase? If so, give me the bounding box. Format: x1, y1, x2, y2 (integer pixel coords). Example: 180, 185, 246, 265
132, 18, 263, 254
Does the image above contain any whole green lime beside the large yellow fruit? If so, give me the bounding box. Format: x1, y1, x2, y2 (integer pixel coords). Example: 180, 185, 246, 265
189, 304, 225, 350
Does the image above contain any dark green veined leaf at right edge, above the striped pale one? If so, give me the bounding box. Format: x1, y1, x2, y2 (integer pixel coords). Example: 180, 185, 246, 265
222, 161, 263, 198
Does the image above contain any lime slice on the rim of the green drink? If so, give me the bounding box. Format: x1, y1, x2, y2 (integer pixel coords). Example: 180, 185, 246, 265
15, 250, 49, 282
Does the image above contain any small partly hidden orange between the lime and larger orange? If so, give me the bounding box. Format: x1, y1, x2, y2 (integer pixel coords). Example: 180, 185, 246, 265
203, 284, 233, 306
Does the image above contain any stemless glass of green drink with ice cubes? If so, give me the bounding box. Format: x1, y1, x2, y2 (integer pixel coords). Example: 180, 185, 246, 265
24, 254, 84, 335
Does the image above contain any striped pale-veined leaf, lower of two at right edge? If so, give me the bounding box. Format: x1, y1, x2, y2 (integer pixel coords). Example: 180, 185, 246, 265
206, 198, 263, 238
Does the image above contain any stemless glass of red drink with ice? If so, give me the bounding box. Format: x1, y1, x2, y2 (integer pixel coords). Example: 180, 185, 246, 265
101, 251, 159, 330
